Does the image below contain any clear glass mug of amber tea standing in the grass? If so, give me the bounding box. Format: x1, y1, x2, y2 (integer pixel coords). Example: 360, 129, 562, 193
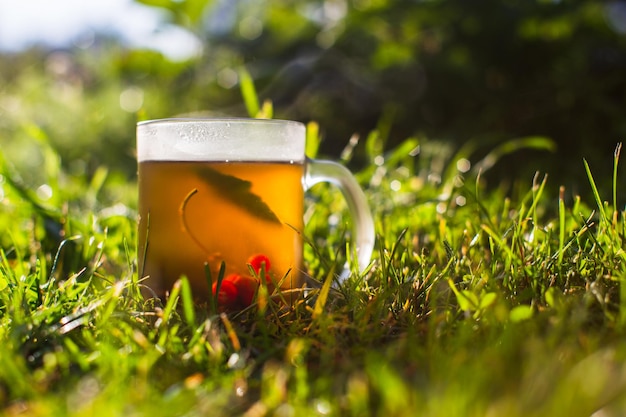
137, 118, 374, 309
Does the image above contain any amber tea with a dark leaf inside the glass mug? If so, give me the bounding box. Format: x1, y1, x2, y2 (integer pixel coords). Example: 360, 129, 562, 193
138, 161, 304, 307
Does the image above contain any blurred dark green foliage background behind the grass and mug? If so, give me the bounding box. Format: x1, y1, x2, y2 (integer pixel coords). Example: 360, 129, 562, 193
0, 0, 626, 194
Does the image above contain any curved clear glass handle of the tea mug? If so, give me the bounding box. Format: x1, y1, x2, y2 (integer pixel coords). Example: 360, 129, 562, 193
304, 158, 375, 281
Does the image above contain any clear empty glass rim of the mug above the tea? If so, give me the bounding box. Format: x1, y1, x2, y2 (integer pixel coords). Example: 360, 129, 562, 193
137, 117, 306, 163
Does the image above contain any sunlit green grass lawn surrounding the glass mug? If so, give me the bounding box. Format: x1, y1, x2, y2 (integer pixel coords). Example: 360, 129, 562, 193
0, 107, 626, 417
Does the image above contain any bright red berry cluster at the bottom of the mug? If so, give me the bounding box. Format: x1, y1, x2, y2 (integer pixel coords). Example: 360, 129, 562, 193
213, 254, 271, 310
